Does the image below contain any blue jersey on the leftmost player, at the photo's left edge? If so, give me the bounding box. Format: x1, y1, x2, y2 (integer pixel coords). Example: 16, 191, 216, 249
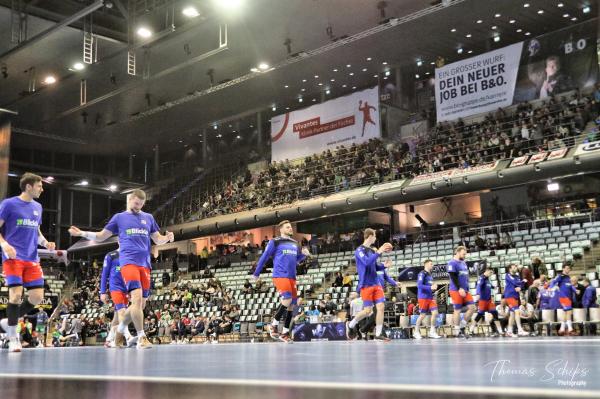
0, 197, 42, 262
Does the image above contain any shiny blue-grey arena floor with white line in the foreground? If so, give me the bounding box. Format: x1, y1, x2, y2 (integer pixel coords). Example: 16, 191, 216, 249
0, 337, 600, 399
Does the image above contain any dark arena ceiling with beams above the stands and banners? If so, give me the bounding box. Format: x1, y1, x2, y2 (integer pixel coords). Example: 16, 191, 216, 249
0, 0, 598, 159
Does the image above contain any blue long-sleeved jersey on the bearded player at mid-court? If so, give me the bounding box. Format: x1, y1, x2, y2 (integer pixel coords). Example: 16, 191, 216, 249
254, 237, 306, 280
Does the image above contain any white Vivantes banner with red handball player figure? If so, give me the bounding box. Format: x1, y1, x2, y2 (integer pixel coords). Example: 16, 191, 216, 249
271, 87, 381, 162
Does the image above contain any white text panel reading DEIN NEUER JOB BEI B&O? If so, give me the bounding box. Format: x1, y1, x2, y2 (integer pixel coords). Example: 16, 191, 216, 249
435, 42, 523, 122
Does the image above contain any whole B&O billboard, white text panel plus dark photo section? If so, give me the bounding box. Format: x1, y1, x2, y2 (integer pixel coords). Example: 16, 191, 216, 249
435, 21, 598, 121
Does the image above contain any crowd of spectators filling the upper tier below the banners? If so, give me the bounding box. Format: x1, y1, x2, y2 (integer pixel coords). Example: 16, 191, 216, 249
156, 89, 600, 228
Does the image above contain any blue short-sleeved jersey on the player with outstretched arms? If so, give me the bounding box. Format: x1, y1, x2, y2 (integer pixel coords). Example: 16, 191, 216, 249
104, 211, 159, 268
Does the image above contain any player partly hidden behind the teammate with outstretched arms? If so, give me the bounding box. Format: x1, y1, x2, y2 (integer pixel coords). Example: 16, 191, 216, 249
100, 249, 135, 348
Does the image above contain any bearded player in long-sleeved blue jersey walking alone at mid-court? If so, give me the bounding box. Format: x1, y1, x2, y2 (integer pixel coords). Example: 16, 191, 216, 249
252, 220, 310, 343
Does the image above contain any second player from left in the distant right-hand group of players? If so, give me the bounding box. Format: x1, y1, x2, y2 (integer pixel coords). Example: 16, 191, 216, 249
447, 246, 475, 338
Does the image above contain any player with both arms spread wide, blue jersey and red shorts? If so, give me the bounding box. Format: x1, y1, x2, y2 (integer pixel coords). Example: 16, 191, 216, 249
69, 189, 175, 349
